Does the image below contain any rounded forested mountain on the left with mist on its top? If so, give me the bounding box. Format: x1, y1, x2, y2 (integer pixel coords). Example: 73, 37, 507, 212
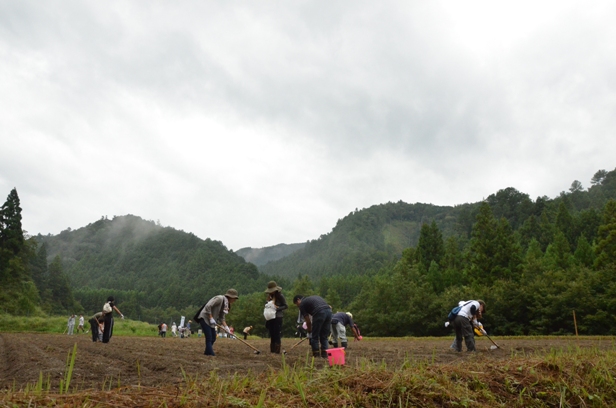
36, 215, 276, 318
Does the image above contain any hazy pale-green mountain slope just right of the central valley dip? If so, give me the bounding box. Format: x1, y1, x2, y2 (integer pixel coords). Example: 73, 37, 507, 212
259, 201, 476, 278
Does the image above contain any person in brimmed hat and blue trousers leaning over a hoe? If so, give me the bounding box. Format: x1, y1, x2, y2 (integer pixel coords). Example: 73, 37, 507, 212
195, 289, 239, 356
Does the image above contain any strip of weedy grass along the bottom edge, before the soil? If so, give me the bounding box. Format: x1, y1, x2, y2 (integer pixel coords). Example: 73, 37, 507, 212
0, 348, 616, 407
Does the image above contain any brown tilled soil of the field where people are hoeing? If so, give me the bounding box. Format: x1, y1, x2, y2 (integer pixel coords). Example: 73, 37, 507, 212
0, 333, 614, 390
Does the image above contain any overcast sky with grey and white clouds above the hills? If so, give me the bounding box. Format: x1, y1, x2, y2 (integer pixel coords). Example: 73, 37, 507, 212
0, 0, 616, 250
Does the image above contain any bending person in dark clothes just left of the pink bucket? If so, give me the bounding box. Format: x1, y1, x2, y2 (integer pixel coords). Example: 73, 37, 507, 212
293, 295, 332, 358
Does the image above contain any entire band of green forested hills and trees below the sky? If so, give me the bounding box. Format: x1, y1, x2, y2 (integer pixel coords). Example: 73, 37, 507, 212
0, 169, 616, 336
